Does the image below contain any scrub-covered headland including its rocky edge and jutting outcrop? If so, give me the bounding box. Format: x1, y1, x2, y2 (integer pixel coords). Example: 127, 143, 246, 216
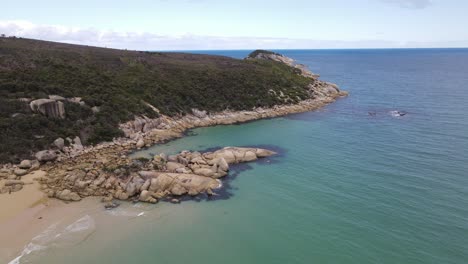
0, 38, 347, 206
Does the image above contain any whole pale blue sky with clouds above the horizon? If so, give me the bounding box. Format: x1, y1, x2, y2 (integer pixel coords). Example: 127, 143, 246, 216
0, 0, 468, 50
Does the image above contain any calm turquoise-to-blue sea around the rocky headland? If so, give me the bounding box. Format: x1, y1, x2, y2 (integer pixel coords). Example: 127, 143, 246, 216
25, 49, 468, 264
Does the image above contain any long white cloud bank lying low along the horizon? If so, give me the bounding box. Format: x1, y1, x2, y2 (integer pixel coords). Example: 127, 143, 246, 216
0, 20, 462, 50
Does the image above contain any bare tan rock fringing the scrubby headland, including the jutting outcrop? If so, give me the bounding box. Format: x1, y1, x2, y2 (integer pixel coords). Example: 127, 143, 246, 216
0, 48, 347, 208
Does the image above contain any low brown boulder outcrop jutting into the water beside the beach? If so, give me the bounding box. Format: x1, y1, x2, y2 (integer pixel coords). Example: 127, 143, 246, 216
40, 144, 275, 203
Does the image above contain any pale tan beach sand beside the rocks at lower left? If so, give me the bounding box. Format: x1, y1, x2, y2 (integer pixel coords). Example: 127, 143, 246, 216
0, 171, 102, 263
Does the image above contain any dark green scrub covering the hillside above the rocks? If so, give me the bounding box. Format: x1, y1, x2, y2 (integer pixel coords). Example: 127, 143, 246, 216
0, 38, 311, 162
